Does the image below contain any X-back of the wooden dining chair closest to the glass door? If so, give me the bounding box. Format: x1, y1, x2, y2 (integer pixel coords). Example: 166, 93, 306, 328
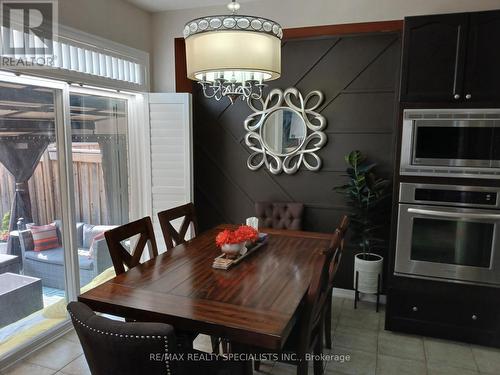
104, 216, 158, 275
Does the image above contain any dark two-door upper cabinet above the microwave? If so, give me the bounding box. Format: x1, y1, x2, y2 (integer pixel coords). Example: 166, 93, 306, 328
401, 11, 500, 103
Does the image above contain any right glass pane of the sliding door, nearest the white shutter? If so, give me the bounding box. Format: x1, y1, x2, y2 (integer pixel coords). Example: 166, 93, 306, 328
70, 90, 129, 287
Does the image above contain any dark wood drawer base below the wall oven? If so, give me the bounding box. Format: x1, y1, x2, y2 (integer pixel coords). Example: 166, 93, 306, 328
386, 280, 500, 347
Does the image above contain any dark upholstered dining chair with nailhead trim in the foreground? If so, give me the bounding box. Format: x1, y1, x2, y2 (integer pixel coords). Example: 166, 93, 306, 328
67, 302, 242, 375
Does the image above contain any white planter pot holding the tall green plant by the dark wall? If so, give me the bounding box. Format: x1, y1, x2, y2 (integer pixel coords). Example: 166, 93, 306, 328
354, 253, 384, 294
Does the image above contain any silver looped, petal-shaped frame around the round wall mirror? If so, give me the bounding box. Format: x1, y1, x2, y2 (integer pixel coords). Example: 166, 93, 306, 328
244, 87, 327, 175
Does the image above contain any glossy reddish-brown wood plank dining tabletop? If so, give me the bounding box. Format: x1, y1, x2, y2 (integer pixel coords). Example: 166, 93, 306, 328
78, 225, 331, 350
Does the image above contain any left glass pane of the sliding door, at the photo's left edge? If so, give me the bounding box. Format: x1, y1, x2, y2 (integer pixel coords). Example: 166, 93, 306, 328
0, 77, 70, 357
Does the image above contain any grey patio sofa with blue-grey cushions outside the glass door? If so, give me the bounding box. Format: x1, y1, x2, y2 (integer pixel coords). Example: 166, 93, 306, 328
19, 220, 116, 289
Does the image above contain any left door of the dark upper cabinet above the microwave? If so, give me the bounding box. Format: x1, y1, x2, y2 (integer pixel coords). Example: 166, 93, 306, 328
401, 13, 468, 102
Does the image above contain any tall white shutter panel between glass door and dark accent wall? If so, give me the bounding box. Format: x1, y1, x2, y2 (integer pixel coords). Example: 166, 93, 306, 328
149, 93, 193, 251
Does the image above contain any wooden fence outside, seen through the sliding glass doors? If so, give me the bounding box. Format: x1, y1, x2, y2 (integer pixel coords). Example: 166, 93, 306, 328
0, 143, 109, 224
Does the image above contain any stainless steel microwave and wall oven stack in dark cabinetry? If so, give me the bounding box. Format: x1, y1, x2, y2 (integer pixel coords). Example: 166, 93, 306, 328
394, 109, 500, 287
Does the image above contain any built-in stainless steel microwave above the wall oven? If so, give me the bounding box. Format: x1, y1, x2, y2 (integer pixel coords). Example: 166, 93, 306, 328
400, 109, 500, 179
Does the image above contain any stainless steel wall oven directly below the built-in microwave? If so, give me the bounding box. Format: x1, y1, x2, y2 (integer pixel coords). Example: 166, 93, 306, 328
395, 183, 500, 286
